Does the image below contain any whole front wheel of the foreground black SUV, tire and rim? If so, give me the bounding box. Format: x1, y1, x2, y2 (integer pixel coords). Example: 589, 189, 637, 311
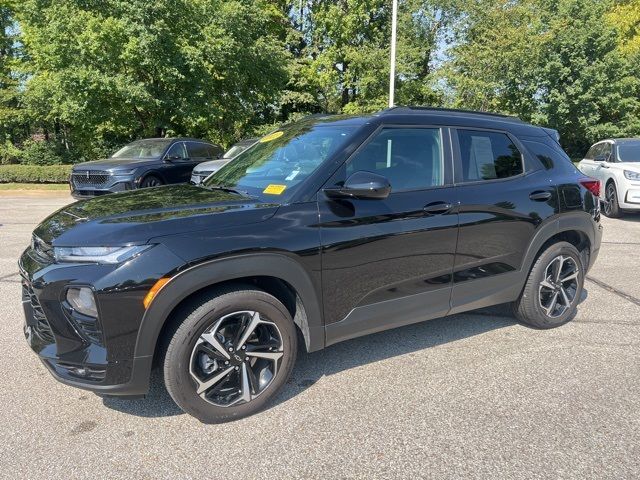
164, 287, 297, 423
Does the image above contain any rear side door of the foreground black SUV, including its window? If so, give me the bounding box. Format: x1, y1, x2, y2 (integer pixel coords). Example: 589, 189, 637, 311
451, 128, 557, 313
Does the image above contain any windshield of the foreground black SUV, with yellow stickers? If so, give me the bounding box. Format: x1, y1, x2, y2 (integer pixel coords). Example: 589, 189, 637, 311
204, 122, 354, 200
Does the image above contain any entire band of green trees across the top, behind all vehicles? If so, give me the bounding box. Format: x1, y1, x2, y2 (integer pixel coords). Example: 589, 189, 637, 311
0, 0, 640, 164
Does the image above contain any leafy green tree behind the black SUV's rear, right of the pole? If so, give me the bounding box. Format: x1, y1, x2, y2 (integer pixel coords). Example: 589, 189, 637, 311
446, 0, 640, 156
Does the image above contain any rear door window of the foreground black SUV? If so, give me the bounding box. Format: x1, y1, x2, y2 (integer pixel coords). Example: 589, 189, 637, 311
458, 130, 523, 182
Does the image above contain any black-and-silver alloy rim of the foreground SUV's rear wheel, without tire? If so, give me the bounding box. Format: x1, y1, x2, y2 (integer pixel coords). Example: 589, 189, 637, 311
538, 255, 580, 318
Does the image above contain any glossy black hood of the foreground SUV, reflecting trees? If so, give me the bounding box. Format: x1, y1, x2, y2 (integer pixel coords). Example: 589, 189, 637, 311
34, 185, 278, 246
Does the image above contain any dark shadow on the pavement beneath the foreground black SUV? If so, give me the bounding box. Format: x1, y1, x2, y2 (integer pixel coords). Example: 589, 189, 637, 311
103, 306, 516, 417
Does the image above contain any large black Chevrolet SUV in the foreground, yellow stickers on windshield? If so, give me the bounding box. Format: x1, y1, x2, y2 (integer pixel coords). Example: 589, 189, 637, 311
20, 108, 602, 422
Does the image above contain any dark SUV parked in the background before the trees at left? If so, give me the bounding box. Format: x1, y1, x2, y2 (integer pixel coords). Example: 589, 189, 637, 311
69, 138, 223, 199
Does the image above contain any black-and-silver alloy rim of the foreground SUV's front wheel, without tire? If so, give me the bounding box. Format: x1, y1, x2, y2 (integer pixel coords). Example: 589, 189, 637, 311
189, 311, 284, 407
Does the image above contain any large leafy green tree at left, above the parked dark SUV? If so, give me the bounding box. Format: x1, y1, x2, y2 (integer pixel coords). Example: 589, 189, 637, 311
18, 0, 287, 157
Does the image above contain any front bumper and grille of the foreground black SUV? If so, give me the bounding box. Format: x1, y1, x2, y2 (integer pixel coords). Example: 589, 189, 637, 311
19, 245, 181, 396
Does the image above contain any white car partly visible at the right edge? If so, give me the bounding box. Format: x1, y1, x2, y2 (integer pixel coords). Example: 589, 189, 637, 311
578, 138, 640, 218
